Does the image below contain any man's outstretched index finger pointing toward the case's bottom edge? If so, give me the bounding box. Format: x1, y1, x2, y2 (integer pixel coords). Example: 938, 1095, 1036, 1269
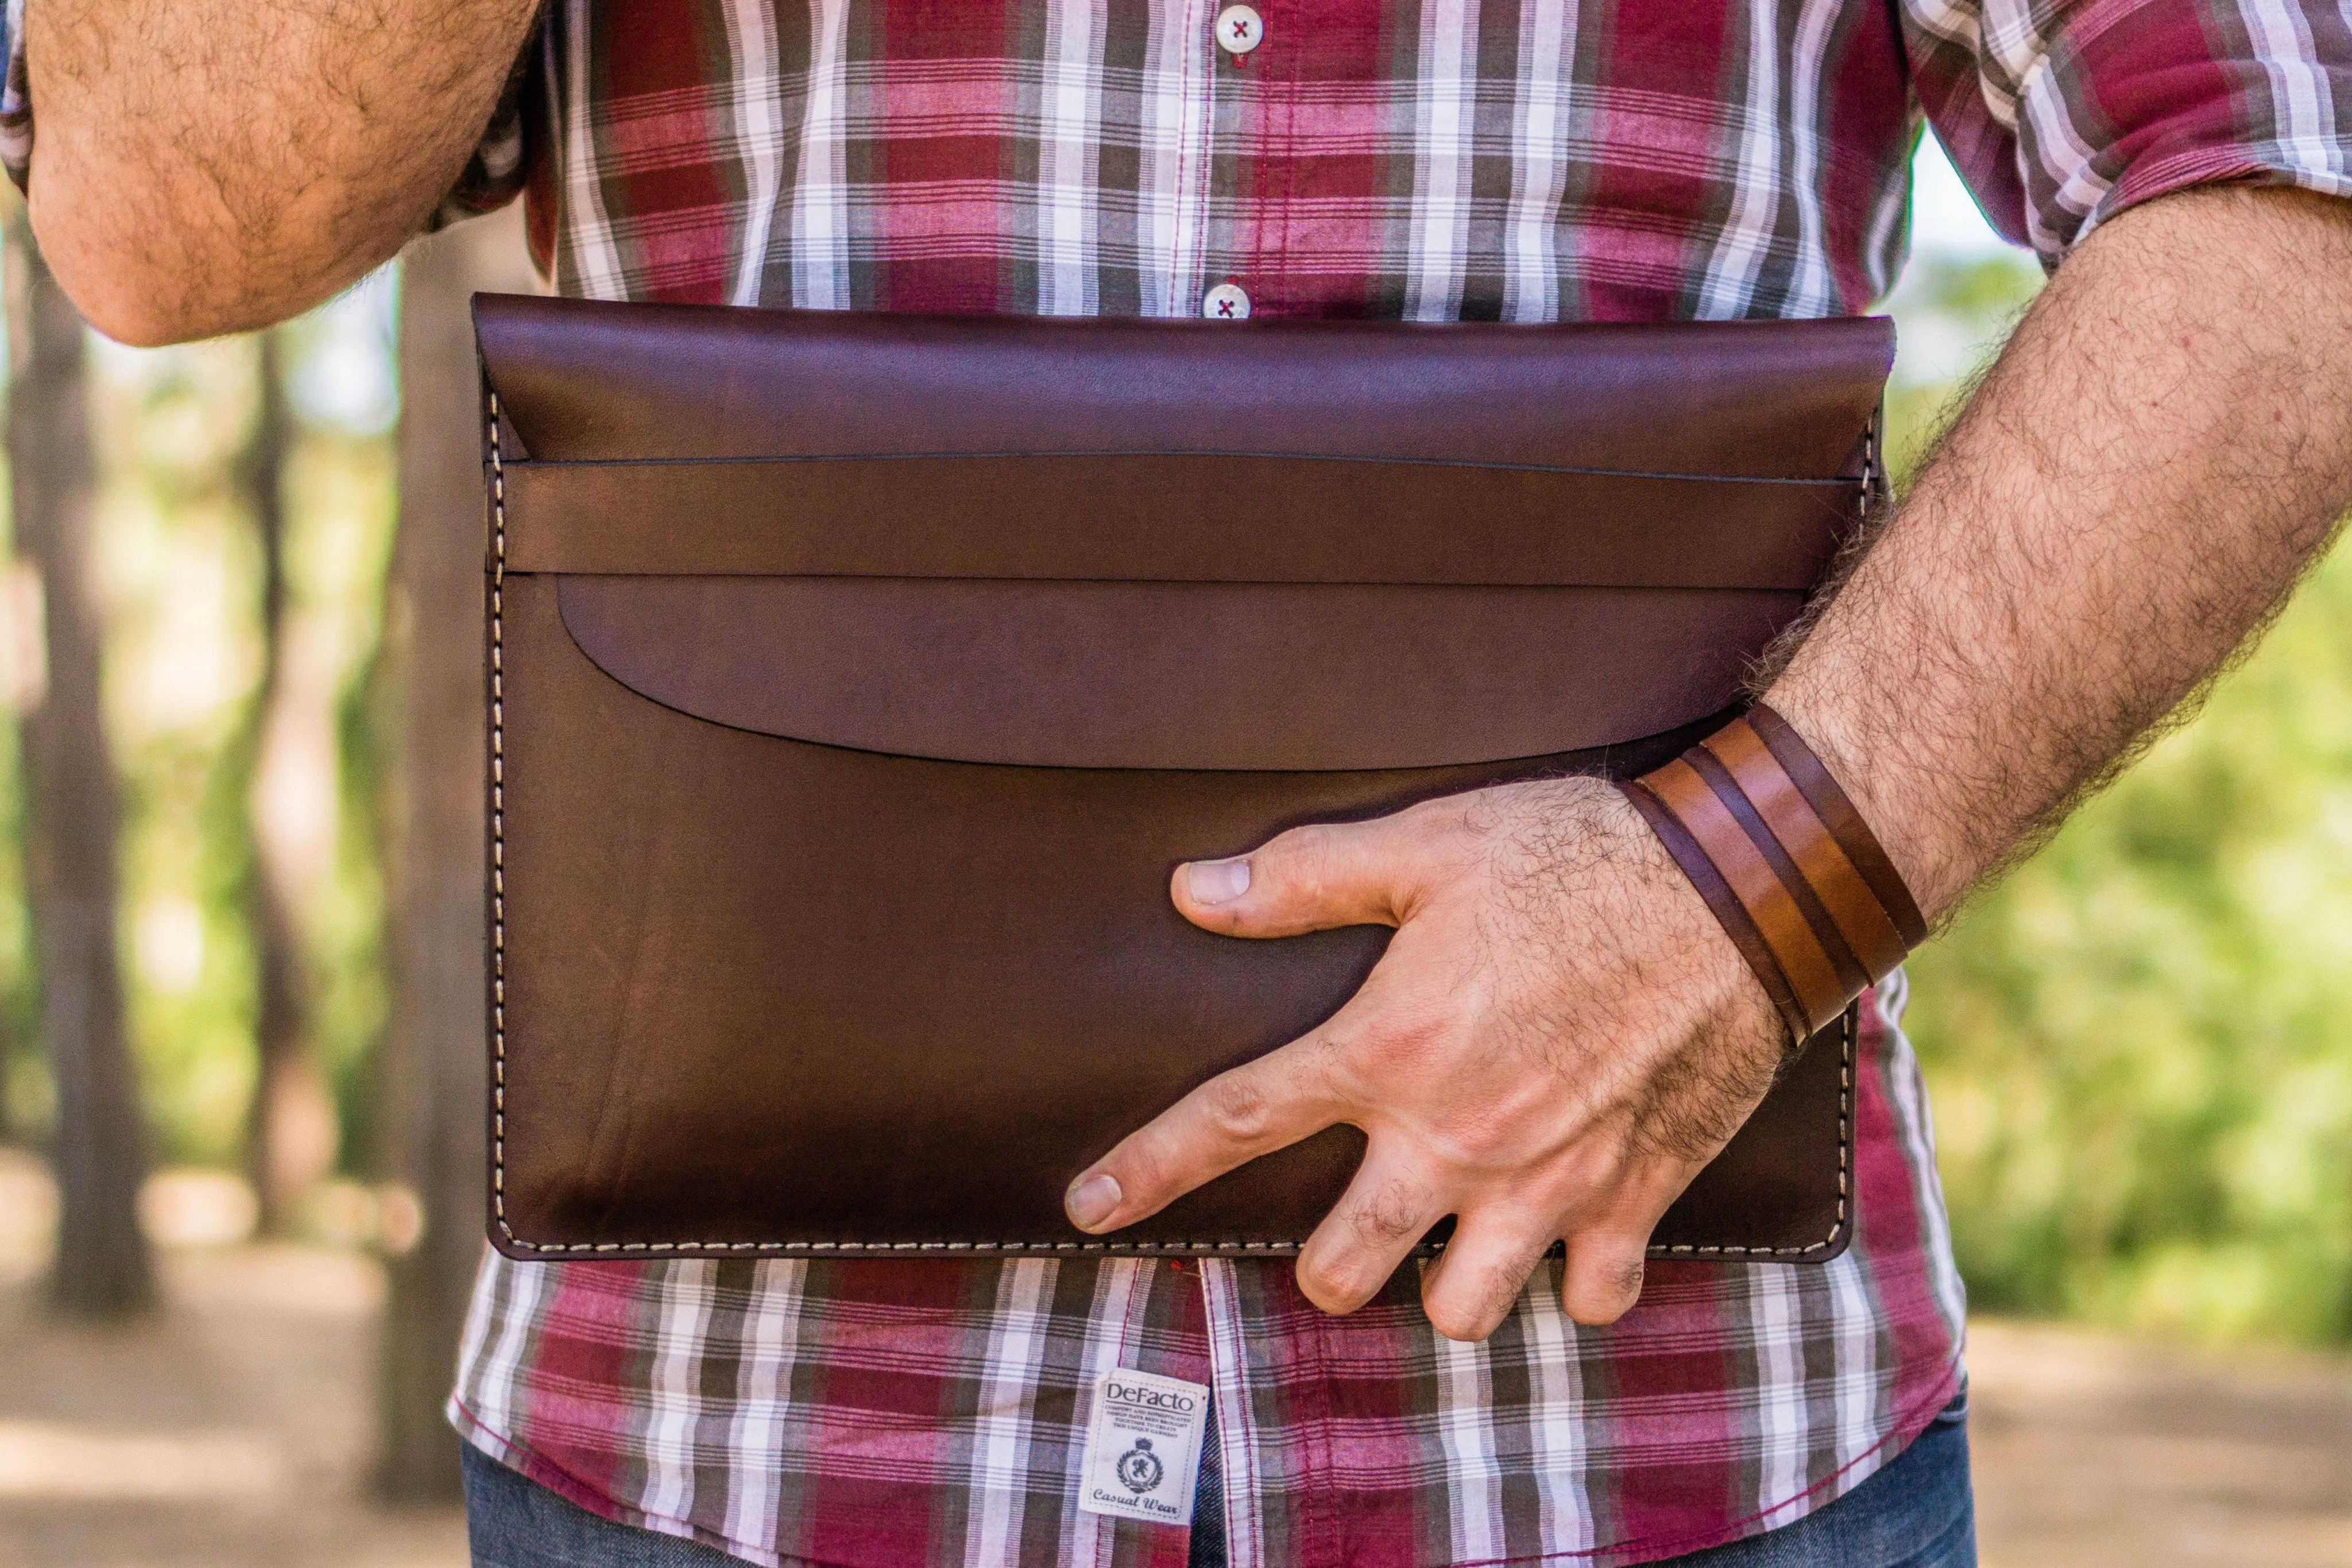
1063, 1029, 1345, 1232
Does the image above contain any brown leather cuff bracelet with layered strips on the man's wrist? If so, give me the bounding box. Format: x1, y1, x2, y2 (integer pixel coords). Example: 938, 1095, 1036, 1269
1625, 703, 1927, 1042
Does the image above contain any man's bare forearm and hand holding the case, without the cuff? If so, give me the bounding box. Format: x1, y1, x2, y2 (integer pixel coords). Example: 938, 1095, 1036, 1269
1070, 191, 2352, 1338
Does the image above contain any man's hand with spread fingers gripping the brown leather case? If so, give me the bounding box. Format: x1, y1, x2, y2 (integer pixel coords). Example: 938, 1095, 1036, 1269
1070, 780, 1785, 1340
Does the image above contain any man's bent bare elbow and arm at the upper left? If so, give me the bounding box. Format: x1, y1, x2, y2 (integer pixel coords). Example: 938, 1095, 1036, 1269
26, 0, 536, 343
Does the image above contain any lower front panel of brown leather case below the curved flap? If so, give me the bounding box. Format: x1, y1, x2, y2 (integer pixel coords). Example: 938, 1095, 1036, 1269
496, 576, 1851, 1258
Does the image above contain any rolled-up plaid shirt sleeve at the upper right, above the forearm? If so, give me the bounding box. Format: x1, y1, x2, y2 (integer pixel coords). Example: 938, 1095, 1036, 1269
1898, 0, 2352, 266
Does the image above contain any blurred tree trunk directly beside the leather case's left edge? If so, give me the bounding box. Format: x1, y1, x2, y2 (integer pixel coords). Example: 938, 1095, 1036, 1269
381, 204, 536, 1500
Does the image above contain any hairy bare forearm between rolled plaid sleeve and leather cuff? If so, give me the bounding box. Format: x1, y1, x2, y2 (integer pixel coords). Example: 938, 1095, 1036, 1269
1766, 191, 2352, 917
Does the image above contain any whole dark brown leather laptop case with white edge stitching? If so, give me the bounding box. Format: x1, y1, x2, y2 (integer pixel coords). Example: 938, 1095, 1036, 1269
477, 299, 1891, 1260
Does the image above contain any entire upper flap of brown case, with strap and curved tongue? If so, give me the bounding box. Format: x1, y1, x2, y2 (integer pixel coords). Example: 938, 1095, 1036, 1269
496, 296, 1893, 771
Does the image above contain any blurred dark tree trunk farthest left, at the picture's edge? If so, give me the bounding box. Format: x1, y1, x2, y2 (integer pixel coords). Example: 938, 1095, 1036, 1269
7, 212, 155, 1317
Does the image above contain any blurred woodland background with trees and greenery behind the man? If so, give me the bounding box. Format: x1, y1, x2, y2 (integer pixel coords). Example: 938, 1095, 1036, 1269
0, 141, 2352, 1568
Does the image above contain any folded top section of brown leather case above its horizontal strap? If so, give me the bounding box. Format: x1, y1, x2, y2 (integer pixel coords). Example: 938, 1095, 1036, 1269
475, 294, 1893, 479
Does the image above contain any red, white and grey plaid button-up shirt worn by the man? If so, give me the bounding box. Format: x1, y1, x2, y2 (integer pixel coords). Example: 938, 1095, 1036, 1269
0, 0, 2352, 1568
